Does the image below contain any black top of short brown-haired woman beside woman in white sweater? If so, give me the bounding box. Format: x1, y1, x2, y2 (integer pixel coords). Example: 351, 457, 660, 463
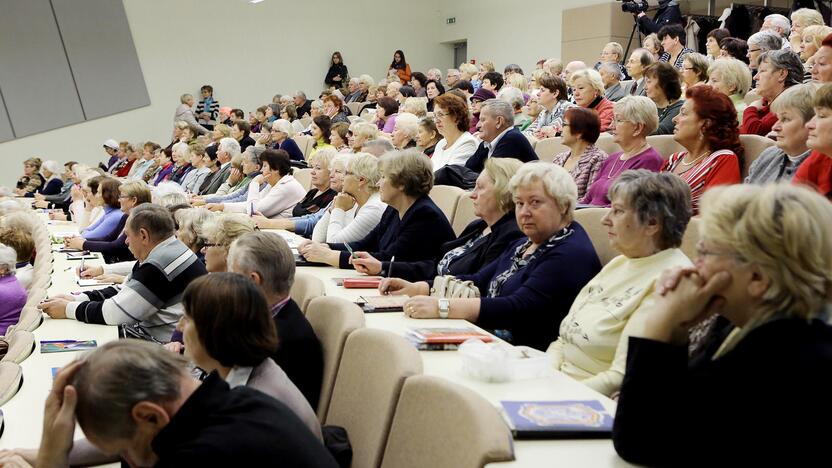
329, 195, 454, 274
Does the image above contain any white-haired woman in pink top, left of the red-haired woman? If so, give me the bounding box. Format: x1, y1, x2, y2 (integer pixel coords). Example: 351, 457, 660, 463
581, 96, 664, 206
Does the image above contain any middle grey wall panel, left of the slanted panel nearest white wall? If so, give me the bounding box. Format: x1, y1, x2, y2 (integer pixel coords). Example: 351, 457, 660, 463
0, 0, 84, 138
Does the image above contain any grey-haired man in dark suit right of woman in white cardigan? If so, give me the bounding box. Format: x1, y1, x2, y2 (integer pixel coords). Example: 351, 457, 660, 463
465, 99, 538, 172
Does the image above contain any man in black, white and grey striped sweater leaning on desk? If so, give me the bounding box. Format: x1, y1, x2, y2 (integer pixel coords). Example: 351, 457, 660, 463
39, 203, 207, 343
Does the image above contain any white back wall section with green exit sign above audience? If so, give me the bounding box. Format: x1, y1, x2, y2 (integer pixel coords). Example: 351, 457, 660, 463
439, 0, 612, 73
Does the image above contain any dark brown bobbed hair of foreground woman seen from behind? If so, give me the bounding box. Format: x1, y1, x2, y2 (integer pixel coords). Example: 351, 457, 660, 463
182, 273, 277, 367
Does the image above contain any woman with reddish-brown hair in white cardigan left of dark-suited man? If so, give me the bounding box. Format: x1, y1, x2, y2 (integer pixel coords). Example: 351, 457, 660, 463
431, 94, 478, 172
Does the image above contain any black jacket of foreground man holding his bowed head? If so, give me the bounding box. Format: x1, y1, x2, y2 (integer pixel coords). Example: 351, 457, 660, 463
151, 372, 338, 468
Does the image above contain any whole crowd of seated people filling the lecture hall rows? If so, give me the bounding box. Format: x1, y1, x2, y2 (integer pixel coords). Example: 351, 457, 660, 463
8, 14, 832, 466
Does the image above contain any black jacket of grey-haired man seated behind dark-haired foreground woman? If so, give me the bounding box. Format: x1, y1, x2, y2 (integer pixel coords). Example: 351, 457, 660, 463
272, 299, 324, 408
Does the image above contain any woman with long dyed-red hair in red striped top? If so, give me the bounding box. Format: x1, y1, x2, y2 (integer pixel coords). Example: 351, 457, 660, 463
661, 85, 744, 215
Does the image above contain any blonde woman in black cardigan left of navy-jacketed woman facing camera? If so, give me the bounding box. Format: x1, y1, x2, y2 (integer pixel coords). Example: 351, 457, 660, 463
352, 158, 523, 281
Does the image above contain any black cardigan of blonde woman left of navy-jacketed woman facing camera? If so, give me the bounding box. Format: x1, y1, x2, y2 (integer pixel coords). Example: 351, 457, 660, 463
392, 211, 523, 281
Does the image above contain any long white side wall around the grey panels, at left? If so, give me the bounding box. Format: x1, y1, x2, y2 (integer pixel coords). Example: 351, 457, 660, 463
0, 0, 452, 186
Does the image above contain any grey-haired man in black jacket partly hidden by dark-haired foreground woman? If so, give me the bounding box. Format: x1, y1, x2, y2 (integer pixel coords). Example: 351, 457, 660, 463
228, 231, 324, 408
